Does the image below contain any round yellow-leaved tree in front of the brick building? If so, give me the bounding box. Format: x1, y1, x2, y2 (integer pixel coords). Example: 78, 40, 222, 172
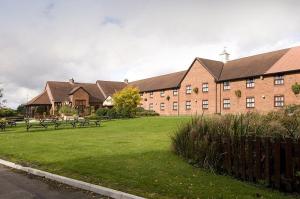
113, 86, 141, 117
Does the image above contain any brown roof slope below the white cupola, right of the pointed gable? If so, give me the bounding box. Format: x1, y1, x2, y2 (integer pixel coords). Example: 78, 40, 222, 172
218, 48, 290, 81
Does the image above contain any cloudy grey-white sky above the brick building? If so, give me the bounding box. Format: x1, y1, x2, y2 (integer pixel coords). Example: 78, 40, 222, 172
0, 0, 300, 107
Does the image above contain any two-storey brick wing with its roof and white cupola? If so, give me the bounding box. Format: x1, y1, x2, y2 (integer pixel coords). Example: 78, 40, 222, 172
130, 47, 300, 115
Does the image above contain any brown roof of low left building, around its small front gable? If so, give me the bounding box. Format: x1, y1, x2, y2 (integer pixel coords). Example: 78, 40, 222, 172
47, 81, 105, 102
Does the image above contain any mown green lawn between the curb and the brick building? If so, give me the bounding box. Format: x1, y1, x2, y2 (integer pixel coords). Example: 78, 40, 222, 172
0, 117, 295, 199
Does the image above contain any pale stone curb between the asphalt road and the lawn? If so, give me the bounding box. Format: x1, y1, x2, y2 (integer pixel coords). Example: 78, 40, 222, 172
0, 159, 145, 199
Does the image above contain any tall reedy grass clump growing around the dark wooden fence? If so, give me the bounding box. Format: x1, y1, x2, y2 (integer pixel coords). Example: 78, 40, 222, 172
171, 107, 300, 171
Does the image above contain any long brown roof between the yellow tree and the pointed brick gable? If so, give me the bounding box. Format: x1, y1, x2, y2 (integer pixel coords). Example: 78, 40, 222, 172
129, 71, 186, 92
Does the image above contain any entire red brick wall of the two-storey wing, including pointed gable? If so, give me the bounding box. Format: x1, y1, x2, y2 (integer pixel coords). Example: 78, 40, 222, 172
142, 61, 300, 115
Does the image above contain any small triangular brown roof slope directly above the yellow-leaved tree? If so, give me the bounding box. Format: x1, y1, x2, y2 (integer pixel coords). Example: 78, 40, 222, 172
97, 80, 127, 99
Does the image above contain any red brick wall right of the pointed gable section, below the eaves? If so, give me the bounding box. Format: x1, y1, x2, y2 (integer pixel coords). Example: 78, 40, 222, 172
220, 74, 300, 114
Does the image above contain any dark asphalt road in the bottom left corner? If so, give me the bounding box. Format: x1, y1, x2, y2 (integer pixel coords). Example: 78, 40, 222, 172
0, 165, 107, 199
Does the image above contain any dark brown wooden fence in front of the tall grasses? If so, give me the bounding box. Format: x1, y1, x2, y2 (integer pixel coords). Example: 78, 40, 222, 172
219, 137, 300, 192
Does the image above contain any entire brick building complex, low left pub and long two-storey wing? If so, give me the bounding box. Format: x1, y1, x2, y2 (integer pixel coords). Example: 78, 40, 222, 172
27, 47, 300, 115
